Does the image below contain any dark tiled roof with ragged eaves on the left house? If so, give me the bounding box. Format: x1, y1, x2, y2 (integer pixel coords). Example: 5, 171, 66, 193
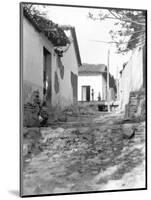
23, 7, 81, 66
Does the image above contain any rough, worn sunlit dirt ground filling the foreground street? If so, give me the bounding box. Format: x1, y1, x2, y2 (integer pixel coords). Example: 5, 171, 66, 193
23, 113, 145, 195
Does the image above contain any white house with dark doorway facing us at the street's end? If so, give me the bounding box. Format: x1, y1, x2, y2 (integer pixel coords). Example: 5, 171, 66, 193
78, 64, 107, 101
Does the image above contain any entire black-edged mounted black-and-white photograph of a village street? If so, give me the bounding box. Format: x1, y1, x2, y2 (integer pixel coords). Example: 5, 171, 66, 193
20, 2, 147, 197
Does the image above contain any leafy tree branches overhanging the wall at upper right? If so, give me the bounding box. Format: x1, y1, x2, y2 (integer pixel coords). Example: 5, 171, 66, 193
88, 9, 146, 53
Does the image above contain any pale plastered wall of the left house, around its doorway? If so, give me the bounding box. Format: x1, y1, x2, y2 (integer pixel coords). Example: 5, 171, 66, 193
23, 17, 78, 108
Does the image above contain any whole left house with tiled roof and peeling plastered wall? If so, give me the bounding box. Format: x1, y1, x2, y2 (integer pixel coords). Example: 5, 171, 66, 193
22, 7, 81, 108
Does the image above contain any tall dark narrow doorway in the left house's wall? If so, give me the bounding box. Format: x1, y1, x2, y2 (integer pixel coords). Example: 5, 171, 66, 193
43, 48, 52, 104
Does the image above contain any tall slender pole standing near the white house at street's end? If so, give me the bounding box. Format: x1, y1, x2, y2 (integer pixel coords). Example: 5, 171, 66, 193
107, 49, 110, 112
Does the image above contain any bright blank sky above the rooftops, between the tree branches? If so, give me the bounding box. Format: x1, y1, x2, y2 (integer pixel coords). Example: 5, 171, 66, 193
34, 6, 129, 78
